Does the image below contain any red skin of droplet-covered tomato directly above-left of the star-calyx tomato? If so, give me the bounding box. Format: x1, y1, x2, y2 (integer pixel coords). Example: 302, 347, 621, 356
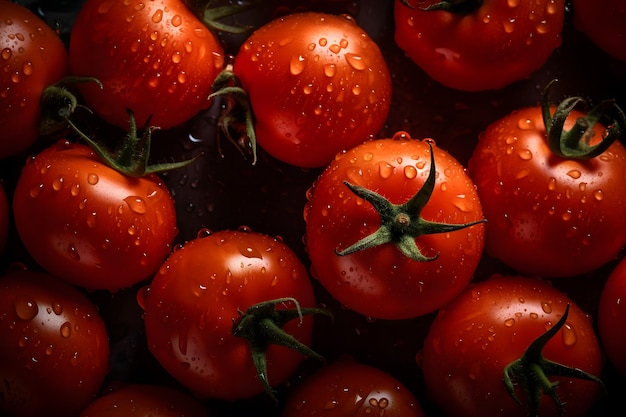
234, 12, 391, 168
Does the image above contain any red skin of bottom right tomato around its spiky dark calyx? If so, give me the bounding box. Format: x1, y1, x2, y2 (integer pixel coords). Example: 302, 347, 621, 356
422, 276, 603, 417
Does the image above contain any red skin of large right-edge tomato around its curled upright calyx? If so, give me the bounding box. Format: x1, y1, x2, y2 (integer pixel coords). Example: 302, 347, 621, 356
468, 107, 626, 277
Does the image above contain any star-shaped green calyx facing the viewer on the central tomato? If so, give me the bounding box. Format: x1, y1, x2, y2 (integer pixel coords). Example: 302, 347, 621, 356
336, 142, 486, 261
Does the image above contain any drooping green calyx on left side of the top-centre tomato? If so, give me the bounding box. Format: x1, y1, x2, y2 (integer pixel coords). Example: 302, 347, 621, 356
209, 65, 257, 165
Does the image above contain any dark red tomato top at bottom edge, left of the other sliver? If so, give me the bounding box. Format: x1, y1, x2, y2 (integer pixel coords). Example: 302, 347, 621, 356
80, 384, 209, 417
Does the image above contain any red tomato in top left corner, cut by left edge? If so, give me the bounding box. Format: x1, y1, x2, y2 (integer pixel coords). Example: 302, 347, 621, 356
0, 0, 68, 158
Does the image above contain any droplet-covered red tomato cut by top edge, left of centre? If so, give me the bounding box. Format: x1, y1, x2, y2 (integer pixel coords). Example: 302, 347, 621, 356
69, 0, 224, 129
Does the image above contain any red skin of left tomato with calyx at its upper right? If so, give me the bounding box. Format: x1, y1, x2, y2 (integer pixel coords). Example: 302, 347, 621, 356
13, 140, 178, 291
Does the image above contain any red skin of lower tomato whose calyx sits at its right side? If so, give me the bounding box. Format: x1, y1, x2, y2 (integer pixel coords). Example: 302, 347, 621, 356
138, 229, 324, 400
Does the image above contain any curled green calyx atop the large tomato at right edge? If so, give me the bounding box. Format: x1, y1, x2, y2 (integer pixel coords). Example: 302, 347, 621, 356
541, 80, 626, 159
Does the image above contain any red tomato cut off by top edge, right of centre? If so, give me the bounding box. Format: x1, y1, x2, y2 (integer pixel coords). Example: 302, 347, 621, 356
395, 0, 565, 91
